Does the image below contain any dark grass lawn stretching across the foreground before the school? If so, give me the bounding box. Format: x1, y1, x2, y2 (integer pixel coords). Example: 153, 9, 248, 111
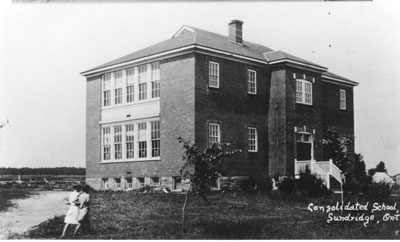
26, 192, 400, 239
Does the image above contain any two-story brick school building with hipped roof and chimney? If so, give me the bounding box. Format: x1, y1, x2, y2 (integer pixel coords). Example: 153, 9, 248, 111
82, 20, 357, 189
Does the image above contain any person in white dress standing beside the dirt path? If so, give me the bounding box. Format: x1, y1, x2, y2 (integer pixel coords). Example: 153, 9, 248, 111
61, 185, 82, 238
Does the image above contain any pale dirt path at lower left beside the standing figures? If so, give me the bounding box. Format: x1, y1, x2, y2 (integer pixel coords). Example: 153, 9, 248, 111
0, 191, 69, 239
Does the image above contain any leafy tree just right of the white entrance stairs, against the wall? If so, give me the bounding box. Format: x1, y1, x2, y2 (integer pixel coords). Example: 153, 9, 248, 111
320, 129, 354, 171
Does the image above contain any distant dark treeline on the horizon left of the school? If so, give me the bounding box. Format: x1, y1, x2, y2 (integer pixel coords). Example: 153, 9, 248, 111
0, 167, 86, 175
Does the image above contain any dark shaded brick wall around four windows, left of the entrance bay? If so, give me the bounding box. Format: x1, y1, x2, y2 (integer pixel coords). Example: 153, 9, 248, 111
195, 54, 269, 175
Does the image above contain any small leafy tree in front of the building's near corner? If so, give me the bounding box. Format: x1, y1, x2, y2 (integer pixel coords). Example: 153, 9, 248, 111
178, 137, 241, 204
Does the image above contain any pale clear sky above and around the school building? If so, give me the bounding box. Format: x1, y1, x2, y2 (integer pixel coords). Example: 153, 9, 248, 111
0, 0, 400, 175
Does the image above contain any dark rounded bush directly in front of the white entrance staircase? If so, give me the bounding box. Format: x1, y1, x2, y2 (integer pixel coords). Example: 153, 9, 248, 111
297, 171, 330, 197
